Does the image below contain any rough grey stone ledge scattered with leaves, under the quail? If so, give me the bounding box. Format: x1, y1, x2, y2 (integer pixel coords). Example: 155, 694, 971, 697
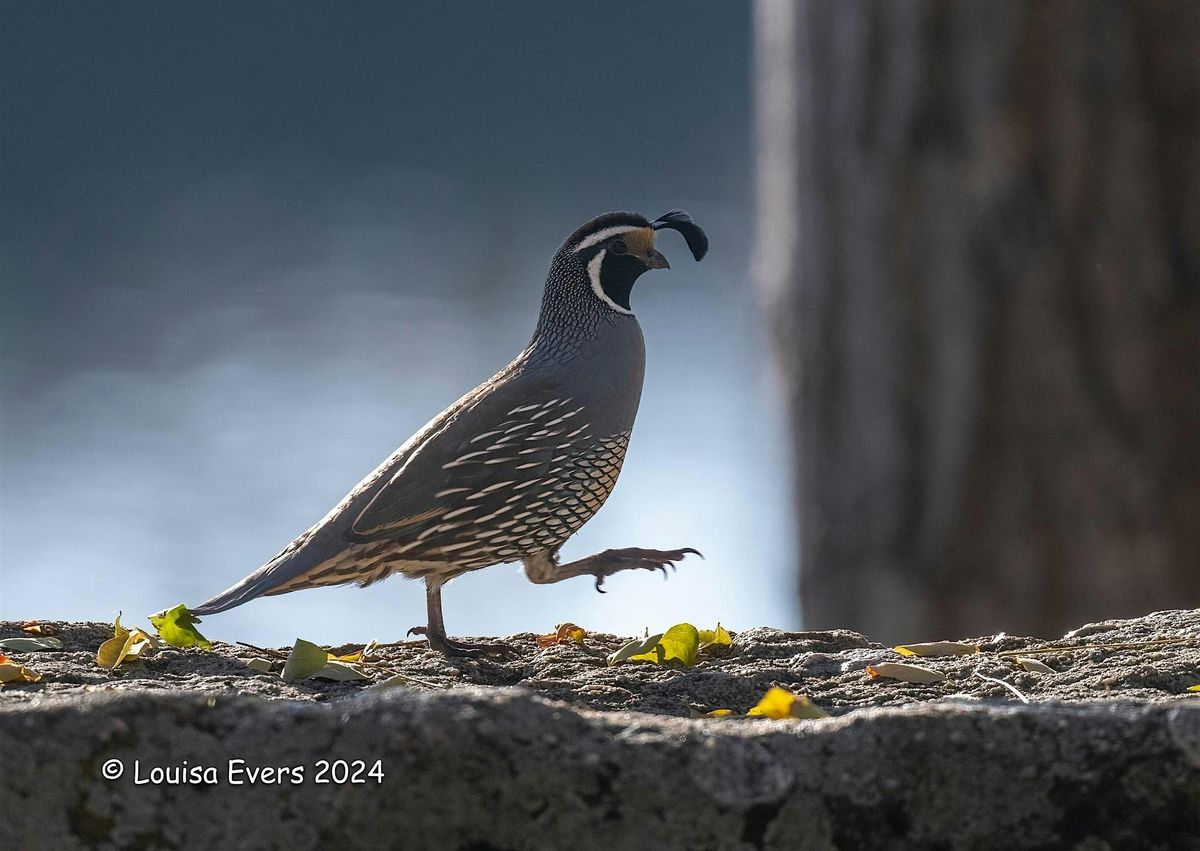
0, 611, 1200, 851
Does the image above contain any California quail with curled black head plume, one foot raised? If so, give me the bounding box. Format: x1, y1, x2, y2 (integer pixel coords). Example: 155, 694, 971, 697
192, 210, 708, 655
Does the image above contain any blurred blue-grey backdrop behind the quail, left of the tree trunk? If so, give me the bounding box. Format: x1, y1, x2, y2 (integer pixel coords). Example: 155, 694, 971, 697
0, 0, 798, 645
